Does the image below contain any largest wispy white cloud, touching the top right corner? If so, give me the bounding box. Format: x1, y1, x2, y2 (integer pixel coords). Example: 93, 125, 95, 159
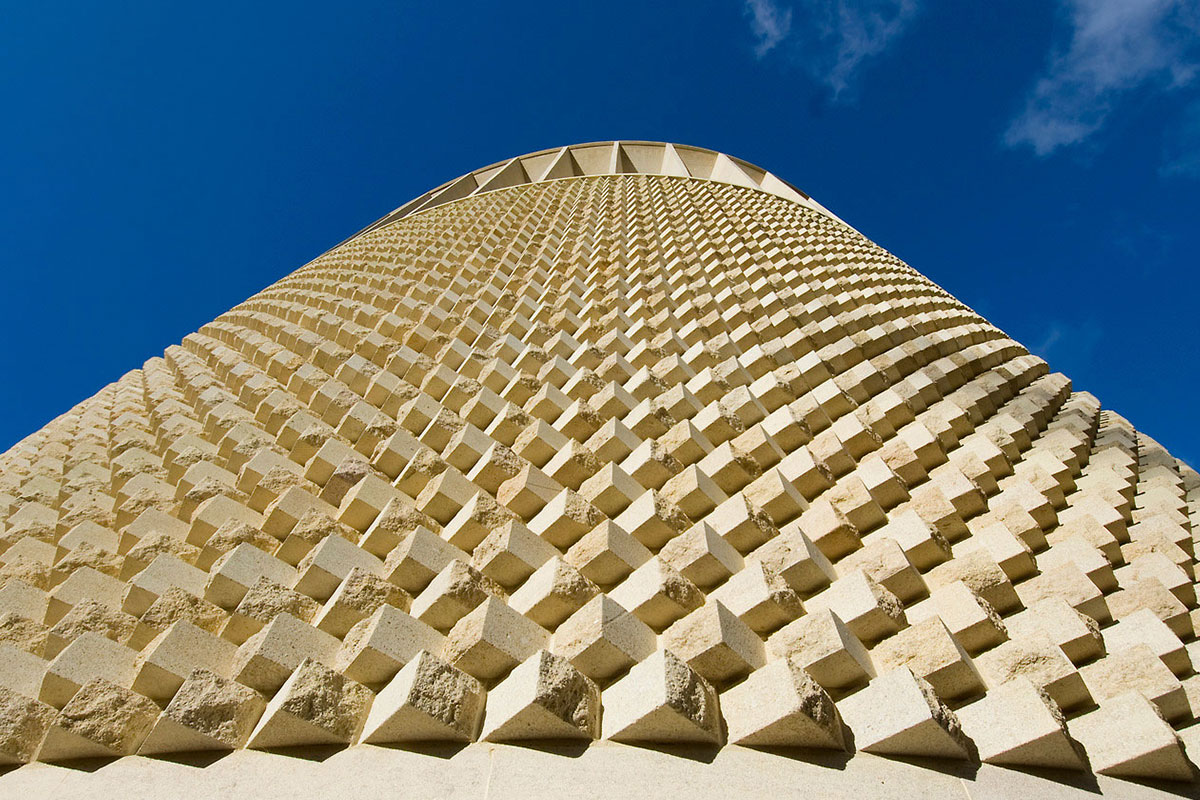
1004, 0, 1200, 156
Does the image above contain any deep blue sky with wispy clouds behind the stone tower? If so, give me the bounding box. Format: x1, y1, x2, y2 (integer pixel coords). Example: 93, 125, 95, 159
0, 0, 1200, 464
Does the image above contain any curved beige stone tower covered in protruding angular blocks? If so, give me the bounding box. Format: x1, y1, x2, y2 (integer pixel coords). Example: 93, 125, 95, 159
0, 142, 1200, 798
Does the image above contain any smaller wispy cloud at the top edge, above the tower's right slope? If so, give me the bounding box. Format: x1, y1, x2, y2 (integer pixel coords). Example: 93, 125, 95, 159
746, 0, 920, 100
